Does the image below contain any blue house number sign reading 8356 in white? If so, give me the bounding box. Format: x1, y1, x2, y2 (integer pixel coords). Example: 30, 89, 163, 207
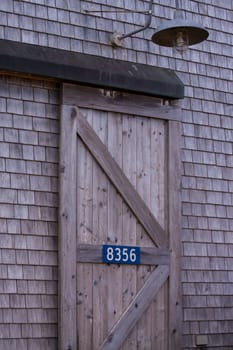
102, 245, 140, 265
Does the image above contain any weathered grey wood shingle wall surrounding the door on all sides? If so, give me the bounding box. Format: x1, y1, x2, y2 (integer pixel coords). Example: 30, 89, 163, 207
0, 0, 233, 350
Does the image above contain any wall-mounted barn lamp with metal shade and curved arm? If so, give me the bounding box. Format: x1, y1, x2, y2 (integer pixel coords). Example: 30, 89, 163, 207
111, 0, 209, 53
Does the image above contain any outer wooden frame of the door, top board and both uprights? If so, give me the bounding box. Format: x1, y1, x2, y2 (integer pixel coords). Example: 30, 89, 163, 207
59, 84, 182, 350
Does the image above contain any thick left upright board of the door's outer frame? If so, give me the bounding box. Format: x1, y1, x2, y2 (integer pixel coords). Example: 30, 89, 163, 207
59, 105, 77, 350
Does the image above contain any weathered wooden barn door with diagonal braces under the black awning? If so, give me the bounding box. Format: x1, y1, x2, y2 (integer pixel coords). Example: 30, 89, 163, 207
59, 84, 180, 350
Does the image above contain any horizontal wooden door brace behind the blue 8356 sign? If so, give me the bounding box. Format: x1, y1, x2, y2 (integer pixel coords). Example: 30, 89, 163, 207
77, 244, 170, 265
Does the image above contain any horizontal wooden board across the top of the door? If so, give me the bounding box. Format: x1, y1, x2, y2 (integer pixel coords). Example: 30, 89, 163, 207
63, 84, 180, 120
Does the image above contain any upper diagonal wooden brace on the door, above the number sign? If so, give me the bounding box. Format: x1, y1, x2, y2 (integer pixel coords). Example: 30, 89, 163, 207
73, 107, 167, 247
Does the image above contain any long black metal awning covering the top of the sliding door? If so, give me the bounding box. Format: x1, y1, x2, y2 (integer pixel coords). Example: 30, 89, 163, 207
0, 40, 184, 99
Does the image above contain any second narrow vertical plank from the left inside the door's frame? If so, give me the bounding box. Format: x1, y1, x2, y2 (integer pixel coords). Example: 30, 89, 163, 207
92, 111, 109, 348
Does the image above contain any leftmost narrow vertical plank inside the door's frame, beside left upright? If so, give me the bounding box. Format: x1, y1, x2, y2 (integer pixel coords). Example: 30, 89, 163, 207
77, 110, 93, 350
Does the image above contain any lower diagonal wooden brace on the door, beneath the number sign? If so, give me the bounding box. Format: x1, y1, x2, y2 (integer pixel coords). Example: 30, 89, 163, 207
98, 266, 169, 350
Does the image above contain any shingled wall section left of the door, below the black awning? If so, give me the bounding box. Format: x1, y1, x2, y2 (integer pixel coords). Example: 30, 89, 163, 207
0, 76, 58, 350
